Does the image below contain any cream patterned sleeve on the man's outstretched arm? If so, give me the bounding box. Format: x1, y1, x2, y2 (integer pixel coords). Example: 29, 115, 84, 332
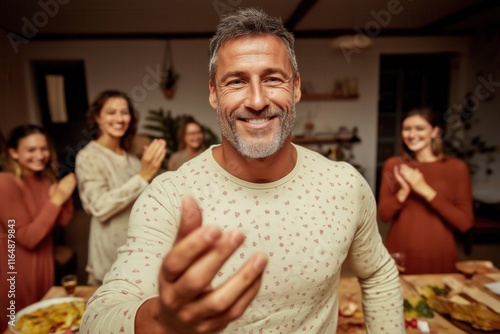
80, 177, 180, 334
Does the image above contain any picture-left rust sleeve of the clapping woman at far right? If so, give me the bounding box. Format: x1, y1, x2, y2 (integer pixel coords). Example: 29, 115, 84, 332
377, 158, 404, 223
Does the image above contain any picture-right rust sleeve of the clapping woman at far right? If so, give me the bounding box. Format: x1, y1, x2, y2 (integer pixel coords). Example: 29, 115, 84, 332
429, 159, 474, 232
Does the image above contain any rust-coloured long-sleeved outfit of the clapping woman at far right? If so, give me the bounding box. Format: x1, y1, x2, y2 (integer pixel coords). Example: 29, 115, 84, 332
377, 157, 474, 274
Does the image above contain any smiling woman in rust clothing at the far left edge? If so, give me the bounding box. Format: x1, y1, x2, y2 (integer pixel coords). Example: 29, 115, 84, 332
0, 125, 76, 331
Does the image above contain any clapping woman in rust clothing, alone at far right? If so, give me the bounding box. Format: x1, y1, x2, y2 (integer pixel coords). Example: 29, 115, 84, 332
378, 109, 473, 274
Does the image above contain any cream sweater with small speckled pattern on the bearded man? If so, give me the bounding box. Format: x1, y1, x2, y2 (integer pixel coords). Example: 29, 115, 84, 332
81, 146, 405, 334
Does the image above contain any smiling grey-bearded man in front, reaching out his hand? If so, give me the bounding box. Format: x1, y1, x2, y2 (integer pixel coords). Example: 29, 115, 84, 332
82, 9, 405, 334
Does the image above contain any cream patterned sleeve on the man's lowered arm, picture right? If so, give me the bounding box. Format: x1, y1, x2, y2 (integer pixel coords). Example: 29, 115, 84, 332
348, 171, 405, 333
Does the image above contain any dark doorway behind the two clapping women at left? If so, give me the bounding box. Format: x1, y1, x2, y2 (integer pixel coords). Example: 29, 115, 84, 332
31, 60, 92, 285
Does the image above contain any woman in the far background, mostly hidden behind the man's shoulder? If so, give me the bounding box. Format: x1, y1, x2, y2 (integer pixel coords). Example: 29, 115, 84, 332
168, 116, 205, 170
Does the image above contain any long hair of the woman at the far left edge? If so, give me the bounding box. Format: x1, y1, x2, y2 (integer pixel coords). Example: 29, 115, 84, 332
3, 124, 57, 182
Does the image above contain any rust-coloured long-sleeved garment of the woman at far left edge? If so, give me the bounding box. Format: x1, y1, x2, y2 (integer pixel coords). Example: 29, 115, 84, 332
0, 173, 73, 331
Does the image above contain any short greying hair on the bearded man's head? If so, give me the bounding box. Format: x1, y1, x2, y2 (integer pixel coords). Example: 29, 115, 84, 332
208, 8, 298, 81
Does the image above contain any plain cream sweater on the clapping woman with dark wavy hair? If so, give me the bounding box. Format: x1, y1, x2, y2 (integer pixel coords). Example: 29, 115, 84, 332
75, 141, 148, 283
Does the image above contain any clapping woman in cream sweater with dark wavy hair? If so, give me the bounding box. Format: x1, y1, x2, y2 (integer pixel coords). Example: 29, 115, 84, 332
75, 90, 167, 285
